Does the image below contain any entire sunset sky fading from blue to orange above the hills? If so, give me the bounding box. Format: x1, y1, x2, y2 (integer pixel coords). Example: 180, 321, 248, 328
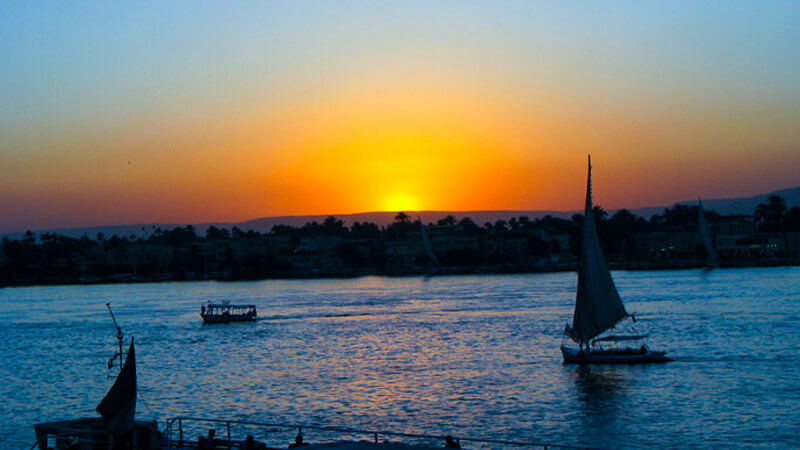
0, 0, 800, 232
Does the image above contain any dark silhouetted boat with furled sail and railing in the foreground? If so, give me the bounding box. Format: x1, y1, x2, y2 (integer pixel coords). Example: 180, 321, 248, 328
26, 304, 612, 450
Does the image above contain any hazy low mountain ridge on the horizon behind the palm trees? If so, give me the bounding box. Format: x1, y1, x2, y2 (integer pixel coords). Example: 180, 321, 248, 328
0, 186, 800, 239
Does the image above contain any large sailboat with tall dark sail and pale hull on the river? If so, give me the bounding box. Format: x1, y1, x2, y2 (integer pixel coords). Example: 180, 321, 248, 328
561, 157, 671, 363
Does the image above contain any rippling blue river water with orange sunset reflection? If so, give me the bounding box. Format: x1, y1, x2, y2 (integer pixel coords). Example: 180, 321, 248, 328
0, 267, 800, 449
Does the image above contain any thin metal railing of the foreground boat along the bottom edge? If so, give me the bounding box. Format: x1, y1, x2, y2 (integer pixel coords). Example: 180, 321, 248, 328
164, 416, 602, 450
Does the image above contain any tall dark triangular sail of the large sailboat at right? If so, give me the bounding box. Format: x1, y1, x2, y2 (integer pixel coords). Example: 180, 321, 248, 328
569, 157, 628, 343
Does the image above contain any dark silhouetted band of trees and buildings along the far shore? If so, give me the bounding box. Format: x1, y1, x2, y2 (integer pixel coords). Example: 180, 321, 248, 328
0, 196, 800, 286
